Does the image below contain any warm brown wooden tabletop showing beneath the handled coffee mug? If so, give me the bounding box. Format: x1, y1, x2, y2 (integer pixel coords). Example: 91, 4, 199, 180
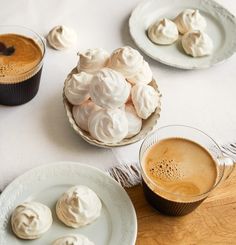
127, 170, 236, 245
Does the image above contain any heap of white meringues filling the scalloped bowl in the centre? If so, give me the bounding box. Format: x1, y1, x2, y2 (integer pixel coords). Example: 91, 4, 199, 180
64, 46, 160, 144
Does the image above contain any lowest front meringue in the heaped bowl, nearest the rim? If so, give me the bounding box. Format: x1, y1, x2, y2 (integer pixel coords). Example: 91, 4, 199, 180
88, 109, 128, 143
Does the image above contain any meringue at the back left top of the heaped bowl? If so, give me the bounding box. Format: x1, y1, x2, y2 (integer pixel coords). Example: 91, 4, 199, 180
77, 48, 110, 74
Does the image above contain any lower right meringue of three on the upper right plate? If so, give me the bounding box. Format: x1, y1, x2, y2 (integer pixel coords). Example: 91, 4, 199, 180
182, 31, 213, 57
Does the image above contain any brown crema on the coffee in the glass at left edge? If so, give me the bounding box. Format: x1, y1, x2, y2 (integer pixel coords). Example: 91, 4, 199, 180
0, 34, 43, 83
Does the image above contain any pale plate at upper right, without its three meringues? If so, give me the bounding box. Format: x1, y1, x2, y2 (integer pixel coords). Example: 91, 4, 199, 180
129, 0, 236, 69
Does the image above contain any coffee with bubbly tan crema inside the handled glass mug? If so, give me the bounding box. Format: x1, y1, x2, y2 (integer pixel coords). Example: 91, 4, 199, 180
142, 138, 217, 215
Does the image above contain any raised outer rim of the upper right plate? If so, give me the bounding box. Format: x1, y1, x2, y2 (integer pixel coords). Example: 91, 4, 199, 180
128, 0, 236, 70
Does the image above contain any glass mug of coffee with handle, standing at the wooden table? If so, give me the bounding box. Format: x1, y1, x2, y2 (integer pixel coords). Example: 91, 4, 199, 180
139, 125, 234, 216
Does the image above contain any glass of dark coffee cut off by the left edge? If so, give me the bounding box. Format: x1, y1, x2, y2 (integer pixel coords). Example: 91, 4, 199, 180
0, 26, 45, 106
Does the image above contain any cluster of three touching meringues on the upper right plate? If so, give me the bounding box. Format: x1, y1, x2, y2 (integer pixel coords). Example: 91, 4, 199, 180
148, 9, 213, 57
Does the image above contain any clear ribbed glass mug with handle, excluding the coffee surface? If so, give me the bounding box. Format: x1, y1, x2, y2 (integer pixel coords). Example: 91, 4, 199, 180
139, 125, 235, 216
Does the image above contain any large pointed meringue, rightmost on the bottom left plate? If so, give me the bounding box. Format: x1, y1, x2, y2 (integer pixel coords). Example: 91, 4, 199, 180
56, 185, 102, 228
